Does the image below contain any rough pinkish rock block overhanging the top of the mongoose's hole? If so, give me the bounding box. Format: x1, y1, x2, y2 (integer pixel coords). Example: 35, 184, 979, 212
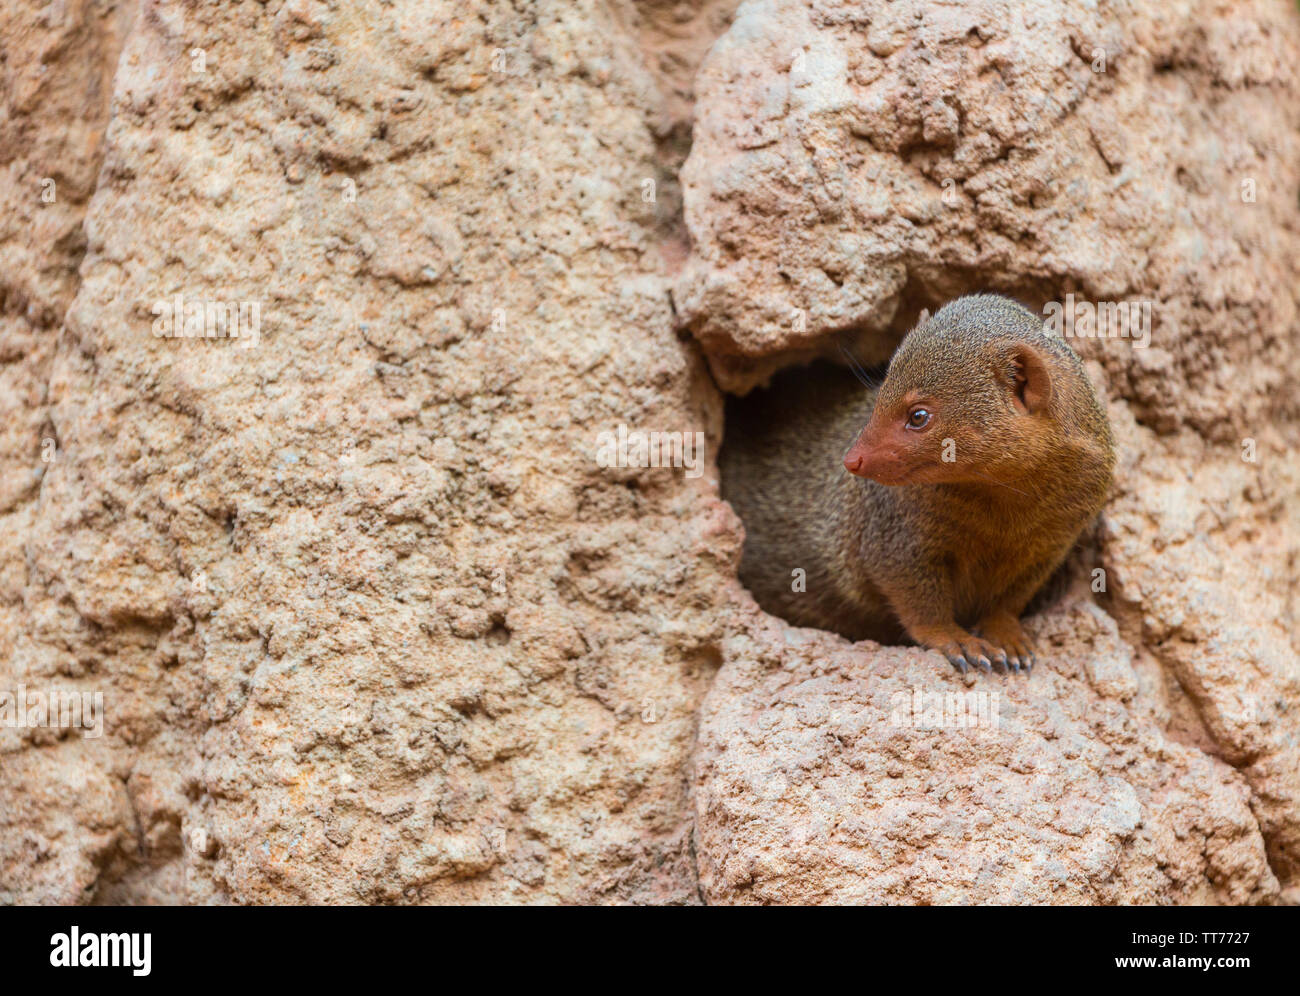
676, 0, 1300, 421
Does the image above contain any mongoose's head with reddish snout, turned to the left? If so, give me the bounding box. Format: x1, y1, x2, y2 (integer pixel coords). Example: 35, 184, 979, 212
844, 294, 1092, 485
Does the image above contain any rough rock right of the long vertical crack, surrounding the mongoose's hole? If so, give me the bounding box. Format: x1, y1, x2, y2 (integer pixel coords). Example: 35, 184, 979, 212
676, 0, 1300, 902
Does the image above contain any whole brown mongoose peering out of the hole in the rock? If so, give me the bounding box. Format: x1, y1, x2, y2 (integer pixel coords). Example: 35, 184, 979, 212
722, 294, 1114, 671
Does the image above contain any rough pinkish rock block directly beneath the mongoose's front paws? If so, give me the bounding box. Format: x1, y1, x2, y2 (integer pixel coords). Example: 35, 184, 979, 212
697, 601, 1278, 905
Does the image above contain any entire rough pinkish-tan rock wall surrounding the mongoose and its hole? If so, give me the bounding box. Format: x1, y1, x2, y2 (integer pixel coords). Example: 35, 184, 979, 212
0, 0, 1300, 904
